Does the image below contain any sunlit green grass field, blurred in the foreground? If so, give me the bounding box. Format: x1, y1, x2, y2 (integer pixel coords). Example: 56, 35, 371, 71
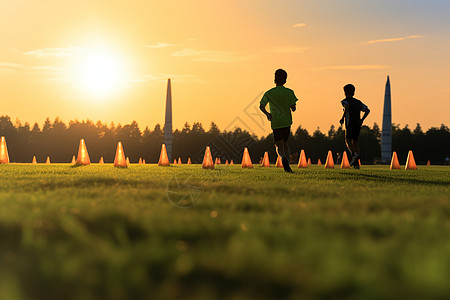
0, 164, 450, 299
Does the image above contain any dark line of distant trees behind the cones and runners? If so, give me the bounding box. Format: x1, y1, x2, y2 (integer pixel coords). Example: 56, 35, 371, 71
0, 116, 450, 164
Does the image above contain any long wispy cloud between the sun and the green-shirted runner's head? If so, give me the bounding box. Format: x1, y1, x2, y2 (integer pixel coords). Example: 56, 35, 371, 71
172, 48, 252, 63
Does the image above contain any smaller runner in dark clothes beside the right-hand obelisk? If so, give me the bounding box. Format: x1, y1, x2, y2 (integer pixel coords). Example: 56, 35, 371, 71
339, 84, 370, 169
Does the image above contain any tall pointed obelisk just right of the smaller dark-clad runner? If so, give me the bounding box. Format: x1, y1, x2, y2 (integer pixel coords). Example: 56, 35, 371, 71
381, 76, 392, 163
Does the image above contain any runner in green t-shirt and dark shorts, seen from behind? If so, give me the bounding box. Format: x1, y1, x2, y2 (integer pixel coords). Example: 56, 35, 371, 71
259, 69, 298, 173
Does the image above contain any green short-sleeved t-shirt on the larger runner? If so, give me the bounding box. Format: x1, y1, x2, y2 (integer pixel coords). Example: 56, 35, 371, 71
260, 86, 298, 129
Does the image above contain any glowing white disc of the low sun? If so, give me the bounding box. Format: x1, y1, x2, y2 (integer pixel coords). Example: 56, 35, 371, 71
74, 49, 126, 98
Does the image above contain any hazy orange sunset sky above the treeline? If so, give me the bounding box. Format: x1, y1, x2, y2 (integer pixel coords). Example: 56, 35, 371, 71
0, 0, 450, 135
